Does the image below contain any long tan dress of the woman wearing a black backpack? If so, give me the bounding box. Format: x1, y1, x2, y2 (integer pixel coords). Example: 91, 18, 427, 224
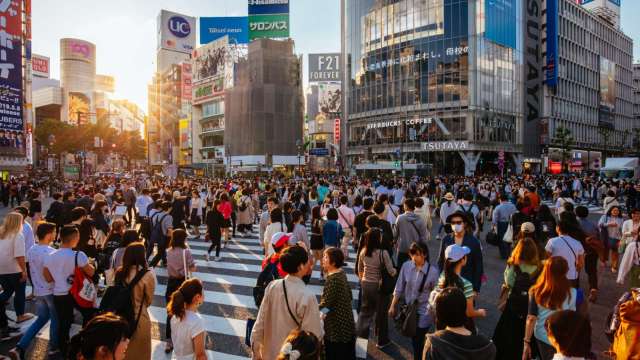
125, 269, 156, 360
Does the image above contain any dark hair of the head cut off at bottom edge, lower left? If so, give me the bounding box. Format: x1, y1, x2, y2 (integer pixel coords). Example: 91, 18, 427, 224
66, 313, 129, 359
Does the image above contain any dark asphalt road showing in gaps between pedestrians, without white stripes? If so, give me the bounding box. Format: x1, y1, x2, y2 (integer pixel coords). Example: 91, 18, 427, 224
0, 201, 625, 359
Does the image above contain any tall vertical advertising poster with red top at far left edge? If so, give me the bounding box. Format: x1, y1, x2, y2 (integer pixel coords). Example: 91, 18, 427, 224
0, 0, 26, 155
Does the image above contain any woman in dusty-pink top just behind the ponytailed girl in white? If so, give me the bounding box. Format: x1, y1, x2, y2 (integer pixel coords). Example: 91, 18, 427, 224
164, 229, 196, 354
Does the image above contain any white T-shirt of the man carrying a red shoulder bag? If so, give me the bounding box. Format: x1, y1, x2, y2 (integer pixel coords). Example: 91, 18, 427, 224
44, 248, 89, 296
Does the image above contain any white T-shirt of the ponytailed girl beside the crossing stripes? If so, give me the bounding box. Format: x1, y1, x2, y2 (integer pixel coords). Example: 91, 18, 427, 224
171, 310, 206, 360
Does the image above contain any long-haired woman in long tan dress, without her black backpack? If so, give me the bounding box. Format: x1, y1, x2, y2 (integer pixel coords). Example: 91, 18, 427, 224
109, 242, 156, 359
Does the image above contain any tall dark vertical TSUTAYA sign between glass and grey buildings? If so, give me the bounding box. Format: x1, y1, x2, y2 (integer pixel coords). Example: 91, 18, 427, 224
523, 0, 543, 158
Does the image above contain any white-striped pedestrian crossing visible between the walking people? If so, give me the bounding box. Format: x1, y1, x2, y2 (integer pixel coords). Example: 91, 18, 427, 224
15, 229, 368, 360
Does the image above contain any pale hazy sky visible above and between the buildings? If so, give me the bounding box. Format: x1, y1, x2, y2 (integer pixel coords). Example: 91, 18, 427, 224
32, 0, 640, 112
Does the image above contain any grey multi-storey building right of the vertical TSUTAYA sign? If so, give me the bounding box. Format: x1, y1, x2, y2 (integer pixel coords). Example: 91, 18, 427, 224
541, 0, 640, 172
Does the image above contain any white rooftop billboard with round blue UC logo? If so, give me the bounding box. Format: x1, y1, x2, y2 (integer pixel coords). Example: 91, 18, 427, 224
158, 10, 196, 54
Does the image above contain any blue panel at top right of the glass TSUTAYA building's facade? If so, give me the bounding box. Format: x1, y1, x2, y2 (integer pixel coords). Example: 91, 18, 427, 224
484, 0, 518, 49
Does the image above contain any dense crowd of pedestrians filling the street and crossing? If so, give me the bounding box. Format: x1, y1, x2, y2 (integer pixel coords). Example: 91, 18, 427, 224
0, 176, 640, 360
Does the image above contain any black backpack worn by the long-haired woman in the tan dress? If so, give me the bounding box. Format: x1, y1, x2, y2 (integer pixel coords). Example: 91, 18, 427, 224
100, 270, 149, 338
